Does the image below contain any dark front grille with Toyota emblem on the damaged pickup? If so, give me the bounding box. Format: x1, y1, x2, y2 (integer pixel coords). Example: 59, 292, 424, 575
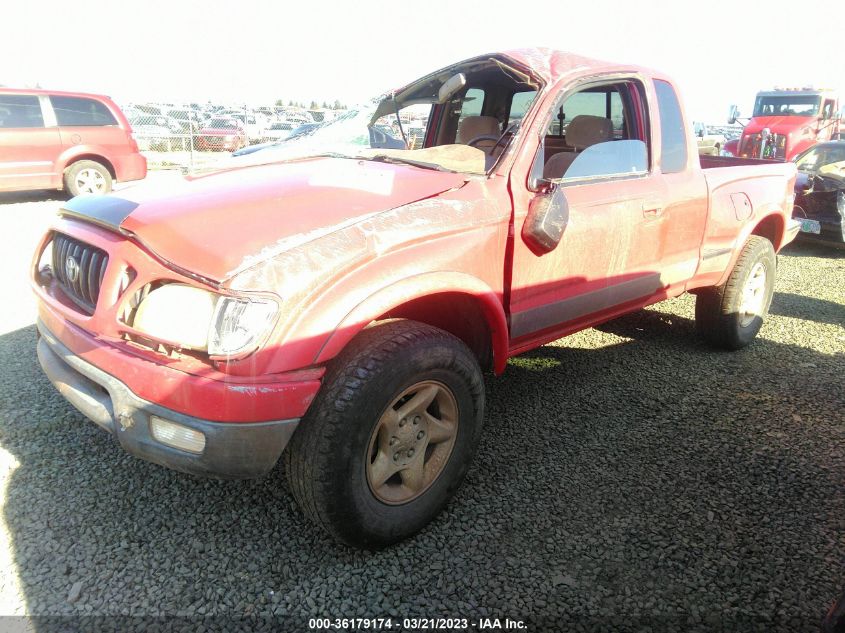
53, 233, 109, 314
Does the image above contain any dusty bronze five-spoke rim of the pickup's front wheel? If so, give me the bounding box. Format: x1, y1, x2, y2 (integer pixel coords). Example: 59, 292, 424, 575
366, 380, 458, 505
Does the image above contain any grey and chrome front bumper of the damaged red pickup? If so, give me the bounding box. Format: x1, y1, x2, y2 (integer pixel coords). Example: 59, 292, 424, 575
38, 321, 299, 479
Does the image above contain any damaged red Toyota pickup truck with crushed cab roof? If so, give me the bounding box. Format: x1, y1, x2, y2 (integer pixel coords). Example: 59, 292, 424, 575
32, 49, 798, 547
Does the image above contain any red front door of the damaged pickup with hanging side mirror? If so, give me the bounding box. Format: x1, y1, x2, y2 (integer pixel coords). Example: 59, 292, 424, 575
510, 76, 664, 351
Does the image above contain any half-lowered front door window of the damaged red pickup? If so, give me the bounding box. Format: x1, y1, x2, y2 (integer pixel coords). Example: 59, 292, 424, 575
532, 80, 648, 184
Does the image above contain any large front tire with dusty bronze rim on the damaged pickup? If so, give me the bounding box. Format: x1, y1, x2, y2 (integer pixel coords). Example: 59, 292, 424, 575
286, 319, 484, 549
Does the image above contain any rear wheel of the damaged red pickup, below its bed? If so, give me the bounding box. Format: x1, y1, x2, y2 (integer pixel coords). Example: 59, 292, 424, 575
695, 235, 776, 350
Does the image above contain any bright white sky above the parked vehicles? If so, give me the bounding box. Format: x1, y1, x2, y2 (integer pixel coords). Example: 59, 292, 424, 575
0, 0, 845, 123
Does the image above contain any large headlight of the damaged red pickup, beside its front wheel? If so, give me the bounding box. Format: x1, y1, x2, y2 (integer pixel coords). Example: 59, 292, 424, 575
132, 283, 279, 357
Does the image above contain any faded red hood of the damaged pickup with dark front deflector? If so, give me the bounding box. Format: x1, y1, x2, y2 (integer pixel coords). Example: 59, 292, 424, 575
62, 158, 466, 282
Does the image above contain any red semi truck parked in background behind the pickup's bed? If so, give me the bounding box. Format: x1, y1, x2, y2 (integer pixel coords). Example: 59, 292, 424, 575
725, 88, 842, 161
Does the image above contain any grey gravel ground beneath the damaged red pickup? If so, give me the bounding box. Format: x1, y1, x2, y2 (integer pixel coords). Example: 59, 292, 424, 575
0, 180, 845, 632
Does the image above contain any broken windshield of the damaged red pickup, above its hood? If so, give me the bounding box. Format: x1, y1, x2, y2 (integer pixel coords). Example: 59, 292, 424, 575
229, 95, 490, 174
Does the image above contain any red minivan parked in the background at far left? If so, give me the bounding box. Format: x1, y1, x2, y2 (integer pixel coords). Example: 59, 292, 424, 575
0, 88, 147, 196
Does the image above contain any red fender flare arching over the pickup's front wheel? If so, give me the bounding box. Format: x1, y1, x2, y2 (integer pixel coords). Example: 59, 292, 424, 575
314, 272, 508, 374
